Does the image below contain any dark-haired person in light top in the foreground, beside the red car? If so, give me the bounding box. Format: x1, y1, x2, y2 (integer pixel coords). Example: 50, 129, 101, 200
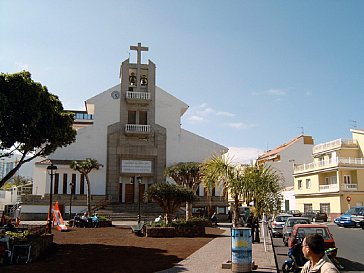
301, 234, 339, 273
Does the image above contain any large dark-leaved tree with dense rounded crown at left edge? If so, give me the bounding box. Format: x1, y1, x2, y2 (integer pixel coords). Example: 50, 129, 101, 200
0, 71, 76, 187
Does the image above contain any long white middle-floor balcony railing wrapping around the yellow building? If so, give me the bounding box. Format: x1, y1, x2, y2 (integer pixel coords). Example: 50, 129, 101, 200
294, 157, 364, 173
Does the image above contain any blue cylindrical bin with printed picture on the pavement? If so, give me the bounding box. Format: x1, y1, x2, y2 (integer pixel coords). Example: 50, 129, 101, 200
231, 228, 252, 272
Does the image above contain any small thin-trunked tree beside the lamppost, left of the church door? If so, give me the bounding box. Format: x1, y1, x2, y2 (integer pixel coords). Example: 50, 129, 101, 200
70, 158, 103, 214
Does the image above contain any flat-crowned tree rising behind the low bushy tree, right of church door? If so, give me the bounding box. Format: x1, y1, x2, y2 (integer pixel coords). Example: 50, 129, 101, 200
164, 162, 201, 220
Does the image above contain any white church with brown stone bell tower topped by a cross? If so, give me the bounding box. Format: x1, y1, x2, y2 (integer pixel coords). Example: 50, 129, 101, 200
22, 43, 227, 217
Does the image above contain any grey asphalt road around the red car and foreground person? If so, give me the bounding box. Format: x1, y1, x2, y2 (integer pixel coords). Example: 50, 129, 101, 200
273, 223, 364, 273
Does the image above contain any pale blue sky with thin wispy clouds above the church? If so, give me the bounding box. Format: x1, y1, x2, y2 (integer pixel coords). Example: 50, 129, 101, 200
0, 0, 364, 160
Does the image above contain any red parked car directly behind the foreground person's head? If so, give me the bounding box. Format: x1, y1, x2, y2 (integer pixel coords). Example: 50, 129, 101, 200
288, 224, 337, 257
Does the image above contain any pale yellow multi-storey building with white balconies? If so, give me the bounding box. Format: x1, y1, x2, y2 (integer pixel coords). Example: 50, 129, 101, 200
293, 129, 364, 221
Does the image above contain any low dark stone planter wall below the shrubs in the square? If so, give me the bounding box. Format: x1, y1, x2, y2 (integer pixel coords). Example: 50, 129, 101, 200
146, 226, 206, 238
